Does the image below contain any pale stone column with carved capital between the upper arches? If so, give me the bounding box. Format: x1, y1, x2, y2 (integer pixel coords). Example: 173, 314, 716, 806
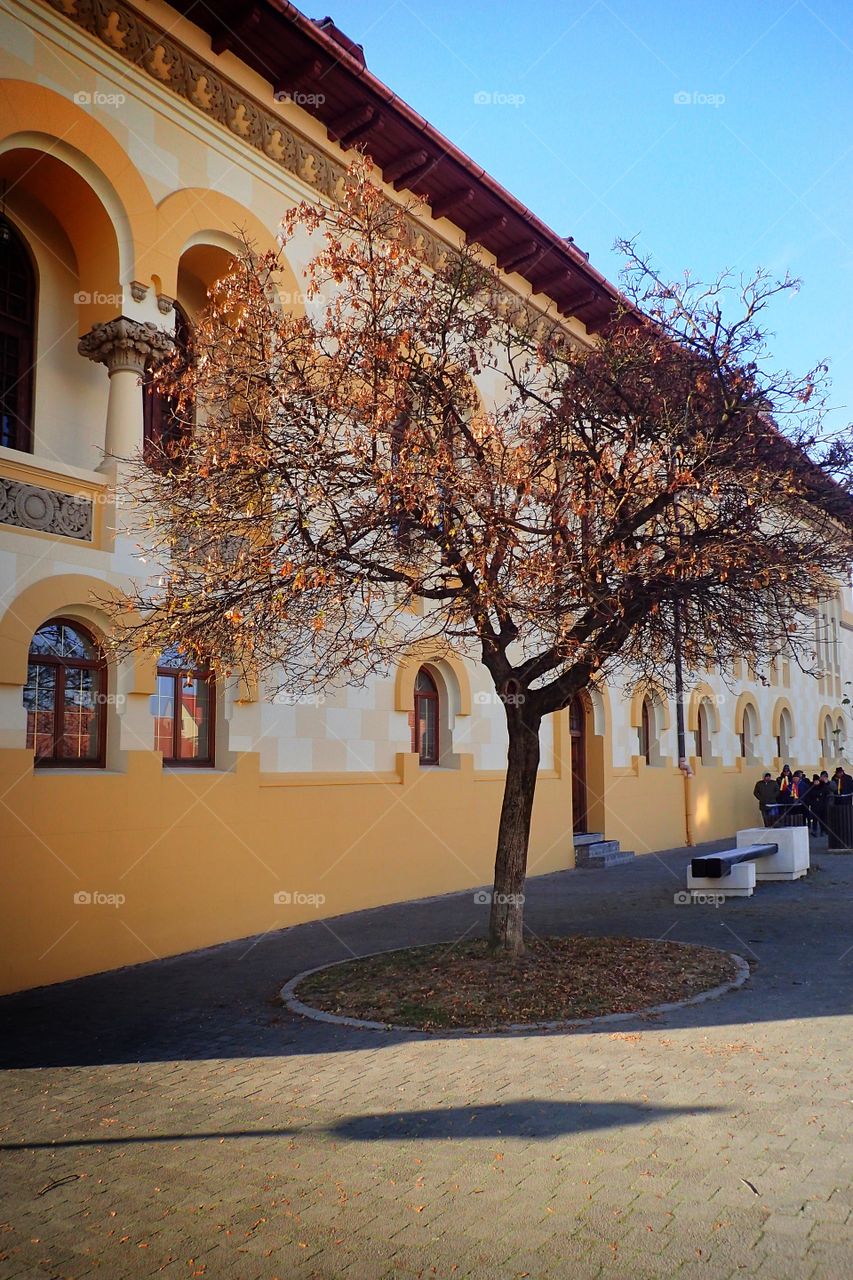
77, 316, 174, 463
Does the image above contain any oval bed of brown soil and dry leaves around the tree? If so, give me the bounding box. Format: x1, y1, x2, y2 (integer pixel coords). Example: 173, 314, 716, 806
295, 936, 738, 1030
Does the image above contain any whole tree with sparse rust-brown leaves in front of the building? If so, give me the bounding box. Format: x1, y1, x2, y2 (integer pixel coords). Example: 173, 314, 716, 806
118, 161, 852, 952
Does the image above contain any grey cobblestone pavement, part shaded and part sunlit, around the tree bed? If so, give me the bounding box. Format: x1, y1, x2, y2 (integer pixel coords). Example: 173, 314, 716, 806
0, 850, 853, 1280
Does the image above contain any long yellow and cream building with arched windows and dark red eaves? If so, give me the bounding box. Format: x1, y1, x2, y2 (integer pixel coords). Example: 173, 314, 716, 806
0, 0, 853, 992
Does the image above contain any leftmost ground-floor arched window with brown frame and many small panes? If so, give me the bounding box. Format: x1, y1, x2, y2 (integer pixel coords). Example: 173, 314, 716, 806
23, 618, 106, 768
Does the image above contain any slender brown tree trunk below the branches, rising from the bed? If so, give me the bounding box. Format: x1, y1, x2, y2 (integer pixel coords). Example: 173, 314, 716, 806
489, 704, 539, 955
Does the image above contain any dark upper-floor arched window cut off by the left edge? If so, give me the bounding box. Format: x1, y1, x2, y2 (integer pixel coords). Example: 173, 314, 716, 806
0, 215, 36, 452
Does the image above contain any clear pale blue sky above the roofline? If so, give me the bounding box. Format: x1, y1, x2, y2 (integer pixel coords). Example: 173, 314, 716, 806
324, 0, 853, 428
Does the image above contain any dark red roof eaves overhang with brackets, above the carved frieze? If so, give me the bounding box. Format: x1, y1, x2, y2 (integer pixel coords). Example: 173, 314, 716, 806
168, 0, 624, 332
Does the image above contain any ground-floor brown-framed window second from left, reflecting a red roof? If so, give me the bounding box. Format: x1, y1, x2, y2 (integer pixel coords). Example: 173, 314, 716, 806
151, 649, 216, 765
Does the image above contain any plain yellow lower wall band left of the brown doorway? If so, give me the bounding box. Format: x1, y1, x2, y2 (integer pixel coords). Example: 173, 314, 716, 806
0, 750, 573, 993
